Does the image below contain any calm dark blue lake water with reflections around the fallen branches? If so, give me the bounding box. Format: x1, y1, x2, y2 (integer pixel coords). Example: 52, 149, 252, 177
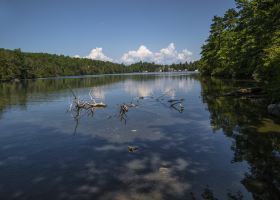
0, 74, 280, 200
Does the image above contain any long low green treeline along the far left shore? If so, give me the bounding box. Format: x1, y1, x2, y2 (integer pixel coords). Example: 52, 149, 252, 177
0, 49, 198, 81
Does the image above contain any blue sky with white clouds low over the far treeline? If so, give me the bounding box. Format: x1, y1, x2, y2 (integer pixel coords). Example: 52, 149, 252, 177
0, 0, 235, 63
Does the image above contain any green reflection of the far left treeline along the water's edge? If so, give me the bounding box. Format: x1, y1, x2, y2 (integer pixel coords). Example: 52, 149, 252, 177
0, 75, 195, 117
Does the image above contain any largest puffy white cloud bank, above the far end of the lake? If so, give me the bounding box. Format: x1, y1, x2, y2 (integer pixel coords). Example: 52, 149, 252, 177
120, 43, 192, 65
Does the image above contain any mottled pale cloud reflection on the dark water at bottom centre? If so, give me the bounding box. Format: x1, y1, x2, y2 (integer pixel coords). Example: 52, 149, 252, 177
76, 154, 194, 200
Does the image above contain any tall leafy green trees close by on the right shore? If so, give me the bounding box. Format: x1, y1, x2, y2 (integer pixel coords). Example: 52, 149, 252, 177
199, 0, 280, 86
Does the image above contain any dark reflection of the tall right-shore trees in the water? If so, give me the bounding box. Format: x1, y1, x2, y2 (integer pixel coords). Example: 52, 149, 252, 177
201, 79, 280, 199
